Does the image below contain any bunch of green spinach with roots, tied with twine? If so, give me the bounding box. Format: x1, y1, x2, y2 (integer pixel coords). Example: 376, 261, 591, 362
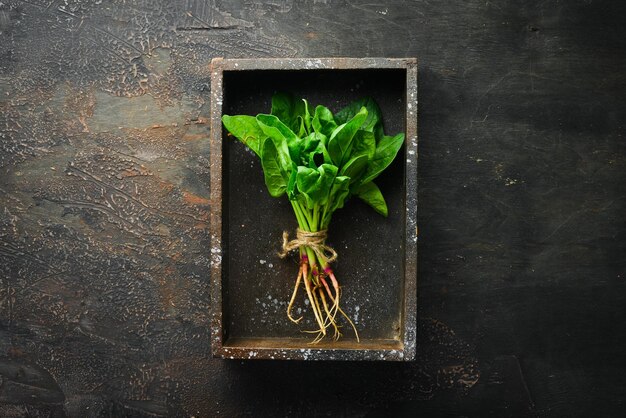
222, 93, 404, 342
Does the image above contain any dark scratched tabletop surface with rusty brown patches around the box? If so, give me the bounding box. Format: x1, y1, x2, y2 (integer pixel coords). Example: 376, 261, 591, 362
0, 0, 626, 417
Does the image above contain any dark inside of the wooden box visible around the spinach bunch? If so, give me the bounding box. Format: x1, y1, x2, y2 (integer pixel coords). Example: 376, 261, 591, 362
222, 69, 406, 349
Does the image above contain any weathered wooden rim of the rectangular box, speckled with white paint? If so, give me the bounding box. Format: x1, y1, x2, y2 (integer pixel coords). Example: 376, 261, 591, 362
210, 58, 418, 361
